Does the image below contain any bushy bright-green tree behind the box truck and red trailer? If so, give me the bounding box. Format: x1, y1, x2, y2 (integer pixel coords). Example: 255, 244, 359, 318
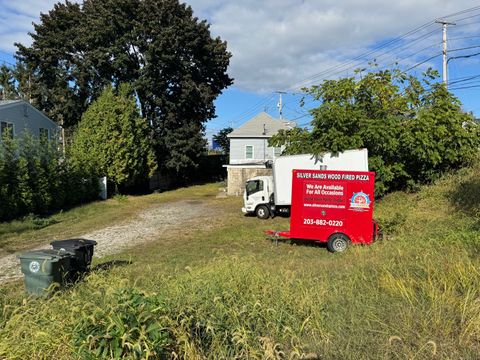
270, 70, 480, 195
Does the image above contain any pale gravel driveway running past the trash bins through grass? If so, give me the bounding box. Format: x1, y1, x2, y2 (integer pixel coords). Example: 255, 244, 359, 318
0, 200, 215, 284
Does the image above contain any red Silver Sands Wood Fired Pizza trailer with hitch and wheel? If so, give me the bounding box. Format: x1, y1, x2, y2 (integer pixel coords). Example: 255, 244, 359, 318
266, 170, 378, 252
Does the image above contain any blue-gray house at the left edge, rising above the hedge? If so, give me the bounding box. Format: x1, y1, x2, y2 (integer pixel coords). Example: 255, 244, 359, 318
0, 100, 61, 141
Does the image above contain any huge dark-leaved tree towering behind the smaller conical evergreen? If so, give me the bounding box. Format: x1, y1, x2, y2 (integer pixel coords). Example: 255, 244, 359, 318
17, 0, 232, 179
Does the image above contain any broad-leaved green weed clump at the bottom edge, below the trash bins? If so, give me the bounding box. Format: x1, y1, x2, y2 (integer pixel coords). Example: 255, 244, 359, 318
73, 288, 173, 359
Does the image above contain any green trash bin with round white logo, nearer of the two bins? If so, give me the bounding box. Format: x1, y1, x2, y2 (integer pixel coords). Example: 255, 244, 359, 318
19, 250, 71, 296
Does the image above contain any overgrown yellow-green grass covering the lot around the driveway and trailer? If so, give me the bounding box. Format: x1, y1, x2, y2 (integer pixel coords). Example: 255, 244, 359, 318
0, 166, 480, 359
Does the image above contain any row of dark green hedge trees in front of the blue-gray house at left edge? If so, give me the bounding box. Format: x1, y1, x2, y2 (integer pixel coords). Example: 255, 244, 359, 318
0, 133, 99, 221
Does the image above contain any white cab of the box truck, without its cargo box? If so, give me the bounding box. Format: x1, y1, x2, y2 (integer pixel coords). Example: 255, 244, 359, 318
242, 176, 273, 219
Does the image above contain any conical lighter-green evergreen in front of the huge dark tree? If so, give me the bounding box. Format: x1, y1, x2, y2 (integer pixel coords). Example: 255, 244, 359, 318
71, 84, 156, 193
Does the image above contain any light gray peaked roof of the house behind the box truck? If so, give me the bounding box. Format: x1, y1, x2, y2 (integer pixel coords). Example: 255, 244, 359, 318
227, 112, 297, 138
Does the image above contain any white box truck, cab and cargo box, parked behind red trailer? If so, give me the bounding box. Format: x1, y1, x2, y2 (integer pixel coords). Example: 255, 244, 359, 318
242, 149, 368, 219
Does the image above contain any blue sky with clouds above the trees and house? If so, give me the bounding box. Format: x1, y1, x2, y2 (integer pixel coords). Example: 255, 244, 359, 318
0, 0, 480, 141
